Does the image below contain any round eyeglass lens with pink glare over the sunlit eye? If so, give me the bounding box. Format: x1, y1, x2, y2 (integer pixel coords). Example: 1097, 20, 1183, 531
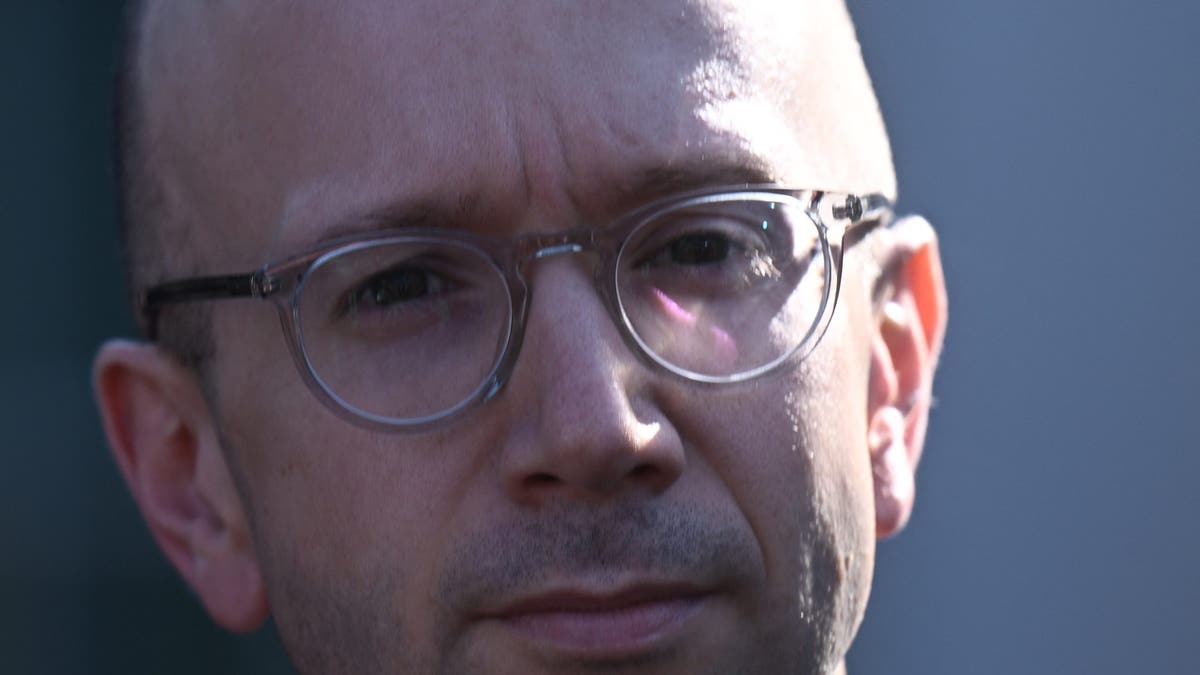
617, 201, 826, 378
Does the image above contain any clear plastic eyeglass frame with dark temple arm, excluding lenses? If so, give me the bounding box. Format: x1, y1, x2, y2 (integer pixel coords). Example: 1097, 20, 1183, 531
142, 185, 892, 431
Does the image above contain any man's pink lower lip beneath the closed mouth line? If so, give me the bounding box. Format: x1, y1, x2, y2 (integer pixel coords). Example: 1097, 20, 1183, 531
504, 597, 703, 658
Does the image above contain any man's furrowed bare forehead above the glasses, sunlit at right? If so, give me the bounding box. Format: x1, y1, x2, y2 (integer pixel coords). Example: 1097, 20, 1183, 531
140, 0, 893, 263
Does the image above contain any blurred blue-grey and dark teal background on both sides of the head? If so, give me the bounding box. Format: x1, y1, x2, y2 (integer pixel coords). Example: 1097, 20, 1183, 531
0, 0, 1200, 675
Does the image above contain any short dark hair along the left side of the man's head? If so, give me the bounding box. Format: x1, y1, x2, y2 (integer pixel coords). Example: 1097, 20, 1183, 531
113, 0, 216, 372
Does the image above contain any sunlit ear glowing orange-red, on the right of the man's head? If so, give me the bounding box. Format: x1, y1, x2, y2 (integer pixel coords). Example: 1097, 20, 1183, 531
866, 217, 946, 538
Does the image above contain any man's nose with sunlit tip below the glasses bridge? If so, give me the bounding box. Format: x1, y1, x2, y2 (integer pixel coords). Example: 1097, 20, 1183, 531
502, 255, 685, 506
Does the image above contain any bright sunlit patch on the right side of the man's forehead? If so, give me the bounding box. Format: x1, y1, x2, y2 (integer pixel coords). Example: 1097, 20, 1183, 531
691, 0, 896, 199
